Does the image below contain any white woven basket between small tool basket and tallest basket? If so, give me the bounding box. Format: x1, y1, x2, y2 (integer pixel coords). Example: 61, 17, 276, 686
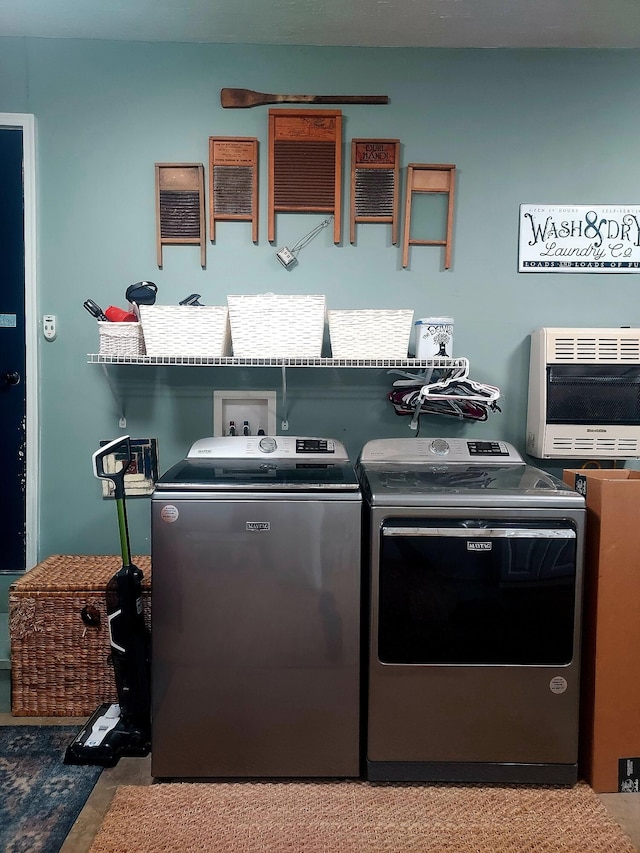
138, 305, 231, 358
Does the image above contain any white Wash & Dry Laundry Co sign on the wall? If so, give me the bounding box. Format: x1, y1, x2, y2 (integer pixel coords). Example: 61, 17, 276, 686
518, 204, 640, 272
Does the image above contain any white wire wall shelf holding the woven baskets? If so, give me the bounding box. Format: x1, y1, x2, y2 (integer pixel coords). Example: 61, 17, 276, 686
87, 353, 469, 370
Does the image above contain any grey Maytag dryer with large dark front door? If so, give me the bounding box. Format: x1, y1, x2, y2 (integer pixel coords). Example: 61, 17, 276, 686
358, 438, 585, 784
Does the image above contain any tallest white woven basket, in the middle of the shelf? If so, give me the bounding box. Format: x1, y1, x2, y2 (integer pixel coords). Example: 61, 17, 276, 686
227, 293, 325, 358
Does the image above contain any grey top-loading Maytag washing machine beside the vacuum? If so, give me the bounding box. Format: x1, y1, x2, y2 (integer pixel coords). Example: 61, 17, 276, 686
151, 436, 362, 778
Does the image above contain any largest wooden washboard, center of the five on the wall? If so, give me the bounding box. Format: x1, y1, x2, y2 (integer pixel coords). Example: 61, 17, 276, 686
269, 109, 342, 243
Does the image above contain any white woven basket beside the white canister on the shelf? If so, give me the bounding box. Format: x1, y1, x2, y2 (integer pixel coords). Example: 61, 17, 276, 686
327, 308, 413, 358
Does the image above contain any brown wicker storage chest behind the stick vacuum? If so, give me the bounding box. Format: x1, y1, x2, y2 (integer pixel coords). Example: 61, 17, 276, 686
9, 555, 151, 717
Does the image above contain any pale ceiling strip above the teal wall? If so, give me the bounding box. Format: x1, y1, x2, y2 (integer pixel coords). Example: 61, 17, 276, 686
0, 0, 640, 48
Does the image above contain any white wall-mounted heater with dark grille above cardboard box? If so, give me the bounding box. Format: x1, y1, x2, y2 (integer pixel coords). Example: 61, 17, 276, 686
527, 328, 640, 459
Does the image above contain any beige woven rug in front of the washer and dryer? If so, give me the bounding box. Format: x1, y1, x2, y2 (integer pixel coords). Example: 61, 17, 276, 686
90, 781, 634, 853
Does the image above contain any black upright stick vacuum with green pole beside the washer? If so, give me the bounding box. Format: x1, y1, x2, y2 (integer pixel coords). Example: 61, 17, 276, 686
64, 435, 151, 767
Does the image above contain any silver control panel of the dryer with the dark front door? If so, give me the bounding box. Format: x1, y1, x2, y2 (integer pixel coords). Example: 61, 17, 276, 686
360, 438, 524, 465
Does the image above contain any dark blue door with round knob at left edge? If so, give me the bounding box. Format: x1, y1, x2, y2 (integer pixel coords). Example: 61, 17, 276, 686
0, 127, 27, 572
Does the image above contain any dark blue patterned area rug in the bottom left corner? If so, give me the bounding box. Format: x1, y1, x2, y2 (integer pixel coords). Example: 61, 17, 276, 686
0, 725, 101, 853
